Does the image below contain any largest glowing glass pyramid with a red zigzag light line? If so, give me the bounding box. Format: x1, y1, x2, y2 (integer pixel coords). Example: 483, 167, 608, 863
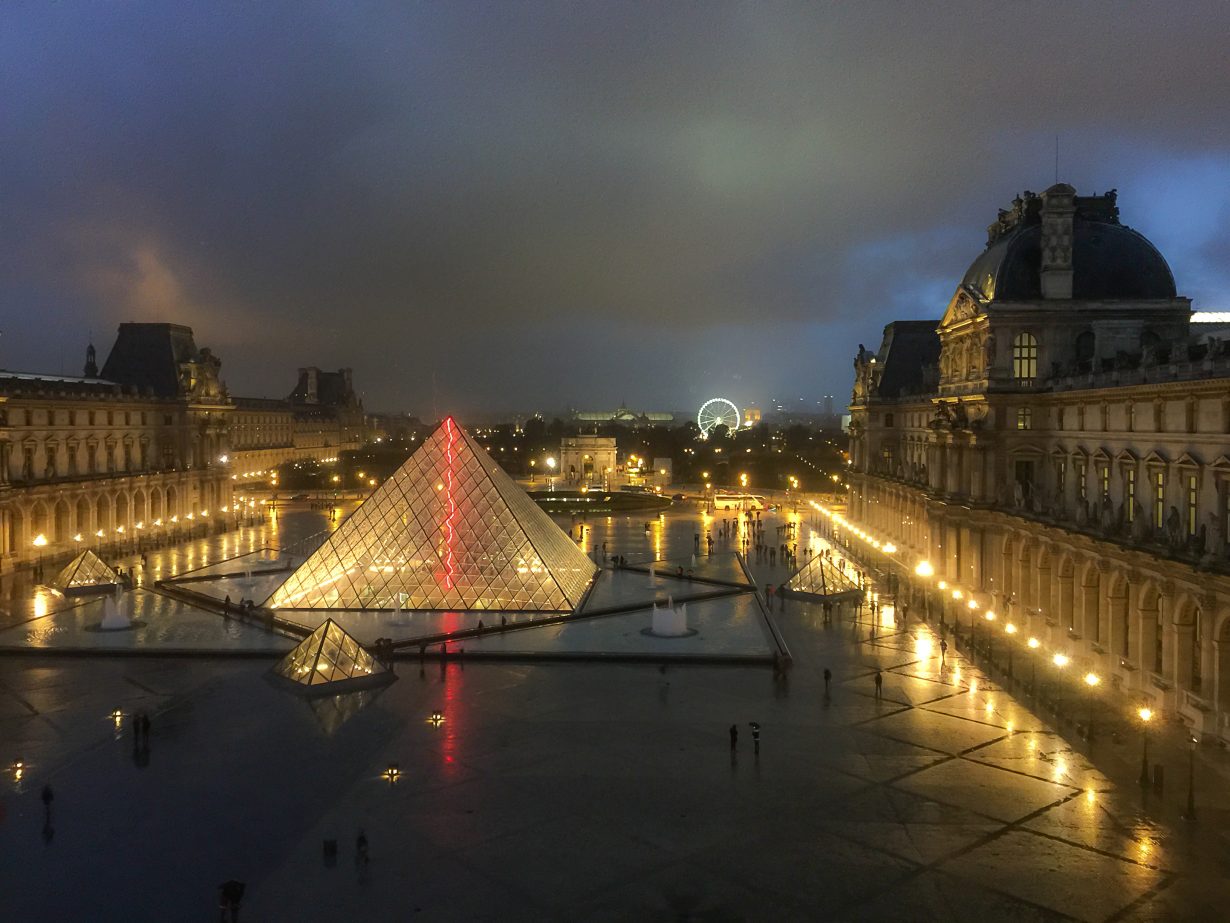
266, 417, 597, 612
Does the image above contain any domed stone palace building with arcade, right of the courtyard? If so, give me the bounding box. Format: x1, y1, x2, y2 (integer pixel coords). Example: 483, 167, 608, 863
849, 185, 1230, 738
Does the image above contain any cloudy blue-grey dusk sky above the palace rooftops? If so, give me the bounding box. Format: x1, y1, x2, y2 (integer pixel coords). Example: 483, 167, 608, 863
0, 0, 1230, 414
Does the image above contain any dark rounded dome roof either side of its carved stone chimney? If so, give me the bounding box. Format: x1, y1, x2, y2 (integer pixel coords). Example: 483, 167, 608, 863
962, 187, 1175, 302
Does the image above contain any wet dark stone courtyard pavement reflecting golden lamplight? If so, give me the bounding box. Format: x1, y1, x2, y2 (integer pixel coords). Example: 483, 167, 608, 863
0, 502, 1230, 923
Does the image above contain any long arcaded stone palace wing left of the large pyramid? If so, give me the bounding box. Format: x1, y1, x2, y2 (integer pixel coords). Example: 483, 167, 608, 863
0, 324, 363, 565
